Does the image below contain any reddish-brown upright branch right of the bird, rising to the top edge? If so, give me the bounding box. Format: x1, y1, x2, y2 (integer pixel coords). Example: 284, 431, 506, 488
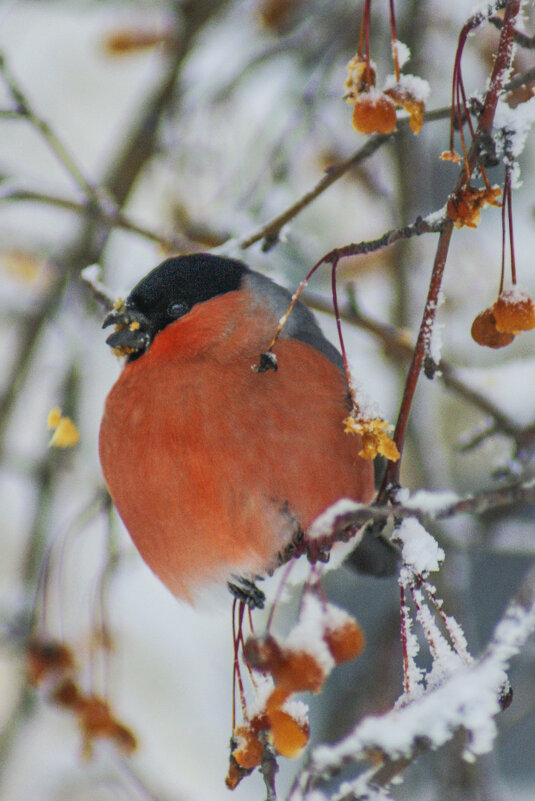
380, 0, 520, 500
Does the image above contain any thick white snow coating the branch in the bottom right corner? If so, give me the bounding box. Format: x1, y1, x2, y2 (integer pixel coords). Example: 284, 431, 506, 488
292, 569, 535, 801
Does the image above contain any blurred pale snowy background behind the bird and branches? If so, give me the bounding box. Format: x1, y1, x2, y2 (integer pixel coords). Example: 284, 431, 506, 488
0, 0, 535, 801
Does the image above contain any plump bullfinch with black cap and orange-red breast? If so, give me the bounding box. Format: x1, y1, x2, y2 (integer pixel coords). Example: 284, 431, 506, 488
99, 254, 374, 602
